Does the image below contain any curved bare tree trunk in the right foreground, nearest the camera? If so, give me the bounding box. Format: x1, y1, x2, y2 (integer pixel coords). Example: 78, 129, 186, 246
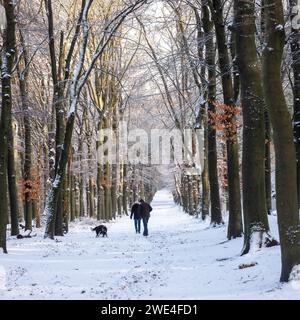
263, 0, 300, 281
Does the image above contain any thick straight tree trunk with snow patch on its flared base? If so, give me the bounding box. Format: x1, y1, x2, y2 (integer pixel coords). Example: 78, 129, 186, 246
234, 0, 270, 250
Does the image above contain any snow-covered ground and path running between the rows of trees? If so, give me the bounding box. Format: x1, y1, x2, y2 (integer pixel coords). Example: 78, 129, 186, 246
0, 190, 300, 299
